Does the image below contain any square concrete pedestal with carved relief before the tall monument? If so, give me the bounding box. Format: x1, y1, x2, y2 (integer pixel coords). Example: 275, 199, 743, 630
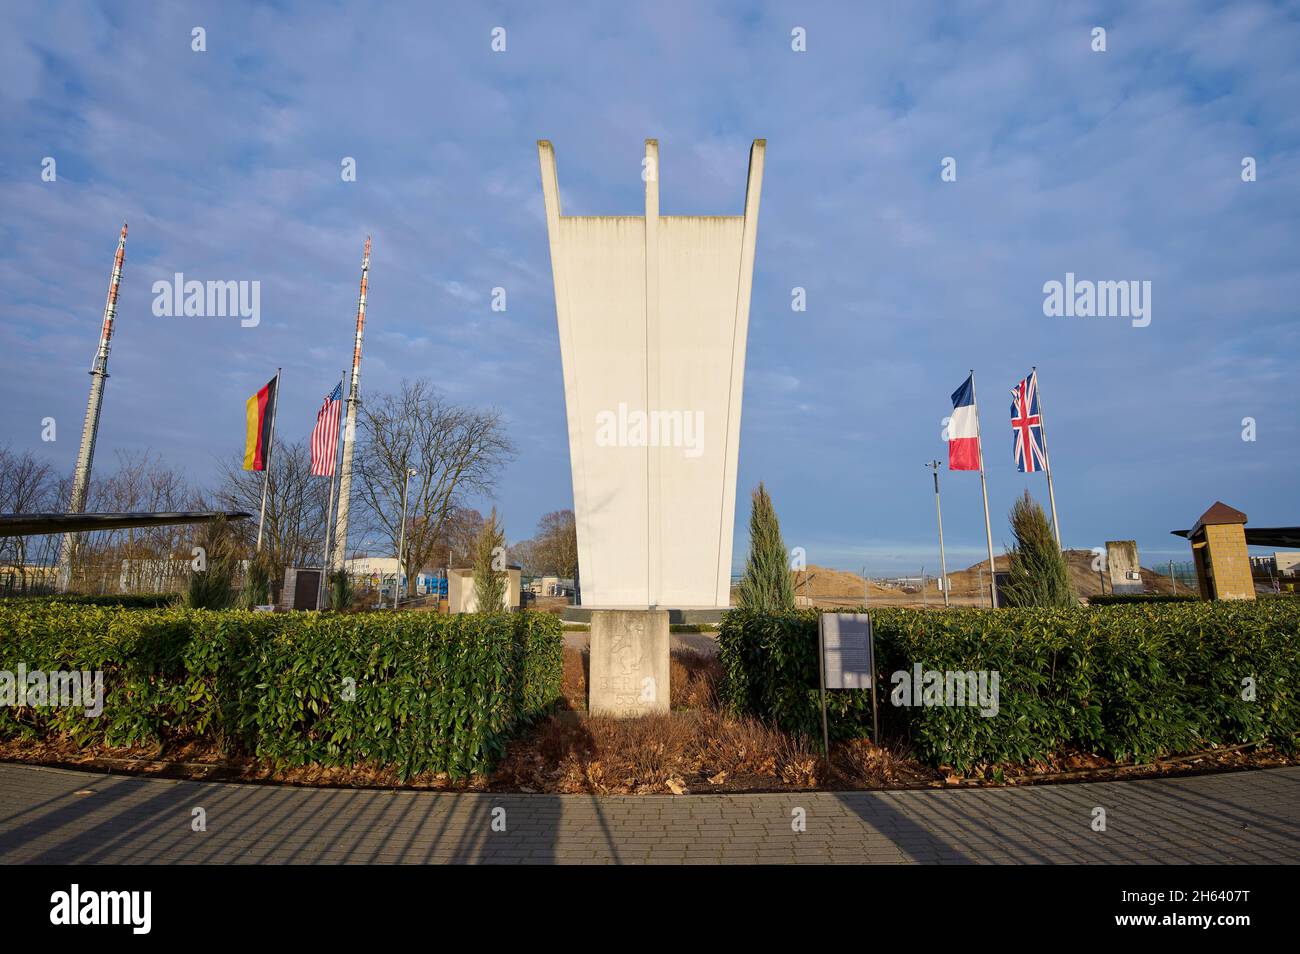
586, 610, 670, 719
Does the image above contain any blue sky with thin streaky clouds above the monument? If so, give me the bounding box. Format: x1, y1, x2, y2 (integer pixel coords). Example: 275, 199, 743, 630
0, 3, 1300, 572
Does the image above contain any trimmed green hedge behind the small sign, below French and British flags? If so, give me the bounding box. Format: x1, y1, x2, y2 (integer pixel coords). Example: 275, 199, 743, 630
719, 600, 1300, 771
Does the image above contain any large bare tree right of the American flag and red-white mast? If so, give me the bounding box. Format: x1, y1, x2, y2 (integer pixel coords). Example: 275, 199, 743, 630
354, 381, 515, 595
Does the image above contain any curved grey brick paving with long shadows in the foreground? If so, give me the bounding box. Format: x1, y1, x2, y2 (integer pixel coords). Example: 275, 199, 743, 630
0, 764, 1300, 864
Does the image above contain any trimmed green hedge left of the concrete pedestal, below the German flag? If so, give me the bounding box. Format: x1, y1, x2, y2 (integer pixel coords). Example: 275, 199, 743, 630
0, 604, 563, 779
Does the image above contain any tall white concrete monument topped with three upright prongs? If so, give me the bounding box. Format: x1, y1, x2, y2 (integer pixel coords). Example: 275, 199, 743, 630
537, 139, 764, 608
